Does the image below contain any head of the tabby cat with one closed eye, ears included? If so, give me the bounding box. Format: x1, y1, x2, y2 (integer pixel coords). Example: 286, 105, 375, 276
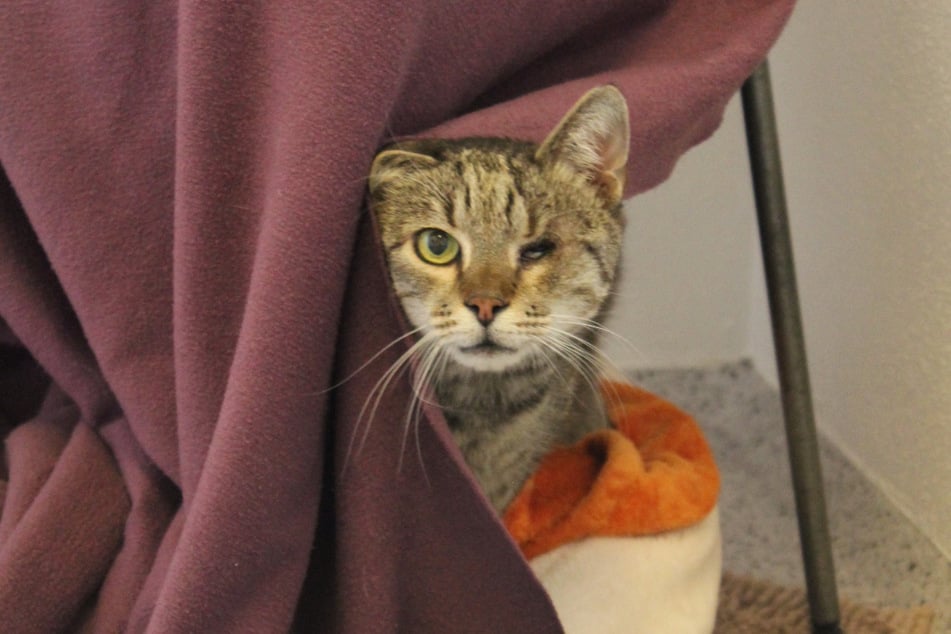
370, 86, 629, 371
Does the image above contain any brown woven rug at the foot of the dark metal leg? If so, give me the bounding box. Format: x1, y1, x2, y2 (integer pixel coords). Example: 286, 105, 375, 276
715, 573, 934, 634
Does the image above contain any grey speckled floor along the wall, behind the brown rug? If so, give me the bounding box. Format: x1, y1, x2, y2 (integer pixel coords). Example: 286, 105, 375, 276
630, 361, 951, 633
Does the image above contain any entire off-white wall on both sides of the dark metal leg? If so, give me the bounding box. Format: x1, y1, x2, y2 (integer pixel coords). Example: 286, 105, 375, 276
609, 0, 951, 554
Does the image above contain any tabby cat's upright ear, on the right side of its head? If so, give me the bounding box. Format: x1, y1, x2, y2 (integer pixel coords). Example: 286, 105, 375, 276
535, 86, 630, 200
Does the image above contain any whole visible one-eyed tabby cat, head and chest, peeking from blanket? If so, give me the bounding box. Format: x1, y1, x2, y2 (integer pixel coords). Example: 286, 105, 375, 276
369, 86, 629, 513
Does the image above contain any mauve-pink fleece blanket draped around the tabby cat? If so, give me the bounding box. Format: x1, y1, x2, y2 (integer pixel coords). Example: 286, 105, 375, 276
0, 0, 792, 633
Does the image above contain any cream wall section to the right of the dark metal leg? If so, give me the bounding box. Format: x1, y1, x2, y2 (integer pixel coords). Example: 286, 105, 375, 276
771, 0, 951, 554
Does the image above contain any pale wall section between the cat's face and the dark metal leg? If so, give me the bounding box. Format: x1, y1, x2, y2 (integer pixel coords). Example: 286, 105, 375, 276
602, 100, 759, 367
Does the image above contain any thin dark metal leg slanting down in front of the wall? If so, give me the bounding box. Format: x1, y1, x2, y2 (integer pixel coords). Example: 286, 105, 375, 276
742, 61, 841, 634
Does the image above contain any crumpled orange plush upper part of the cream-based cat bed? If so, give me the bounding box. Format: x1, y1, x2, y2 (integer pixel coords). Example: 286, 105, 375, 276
504, 382, 720, 559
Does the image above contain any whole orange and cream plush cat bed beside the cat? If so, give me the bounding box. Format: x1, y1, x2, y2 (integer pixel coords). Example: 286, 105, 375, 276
504, 383, 721, 634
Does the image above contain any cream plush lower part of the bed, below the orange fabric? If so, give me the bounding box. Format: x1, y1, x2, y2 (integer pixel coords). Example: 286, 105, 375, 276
531, 508, 722, 634
